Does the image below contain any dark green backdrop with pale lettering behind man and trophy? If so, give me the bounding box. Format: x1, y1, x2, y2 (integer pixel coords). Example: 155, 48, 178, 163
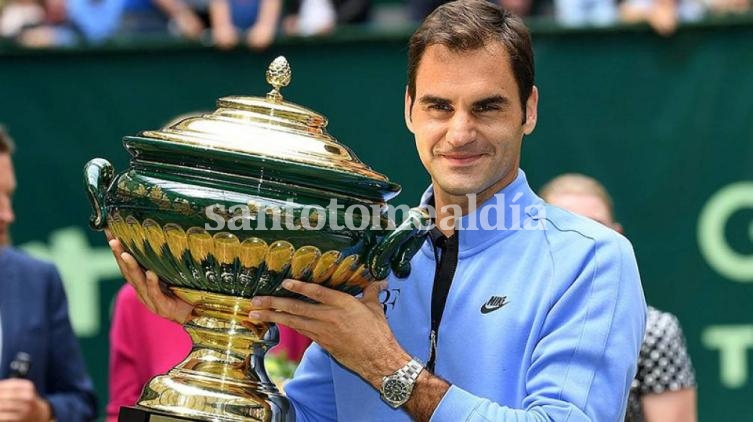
0, 16, 753, 421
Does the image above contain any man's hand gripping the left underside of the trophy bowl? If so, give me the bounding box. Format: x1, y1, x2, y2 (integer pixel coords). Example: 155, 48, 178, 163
105, 231, 193, 324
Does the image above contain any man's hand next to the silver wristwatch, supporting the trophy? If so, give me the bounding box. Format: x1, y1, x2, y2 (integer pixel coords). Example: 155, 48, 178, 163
249, 280, 411, 388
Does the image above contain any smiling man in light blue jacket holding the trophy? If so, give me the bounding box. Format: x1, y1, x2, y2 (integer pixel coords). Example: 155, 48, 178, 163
111, 0, 645, 422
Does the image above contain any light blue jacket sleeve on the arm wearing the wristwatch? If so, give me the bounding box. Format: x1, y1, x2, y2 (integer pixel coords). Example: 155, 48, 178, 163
431, 233, 646, 422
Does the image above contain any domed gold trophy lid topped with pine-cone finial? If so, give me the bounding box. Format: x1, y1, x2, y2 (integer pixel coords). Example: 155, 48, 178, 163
131, 56, 400, 200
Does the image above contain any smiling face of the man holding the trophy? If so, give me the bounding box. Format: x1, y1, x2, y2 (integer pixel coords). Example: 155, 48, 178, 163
405, 42, 538, 204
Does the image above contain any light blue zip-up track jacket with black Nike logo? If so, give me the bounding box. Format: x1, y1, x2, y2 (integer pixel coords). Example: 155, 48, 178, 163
285, 171, 646, 422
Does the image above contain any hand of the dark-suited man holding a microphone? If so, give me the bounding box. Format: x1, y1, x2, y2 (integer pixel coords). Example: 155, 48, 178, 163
0, 378, 52, 422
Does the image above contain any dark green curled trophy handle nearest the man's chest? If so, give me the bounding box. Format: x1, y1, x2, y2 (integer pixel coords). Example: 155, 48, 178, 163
367, 207, 431, 280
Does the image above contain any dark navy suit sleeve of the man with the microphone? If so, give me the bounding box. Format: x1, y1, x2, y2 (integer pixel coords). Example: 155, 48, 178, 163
42, 267, 97, 422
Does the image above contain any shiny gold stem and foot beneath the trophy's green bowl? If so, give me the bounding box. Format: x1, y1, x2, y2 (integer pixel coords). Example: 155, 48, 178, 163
138, 288, 290, 422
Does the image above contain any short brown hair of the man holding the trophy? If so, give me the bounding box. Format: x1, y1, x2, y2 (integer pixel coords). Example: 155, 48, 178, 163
408, 0, 534, 122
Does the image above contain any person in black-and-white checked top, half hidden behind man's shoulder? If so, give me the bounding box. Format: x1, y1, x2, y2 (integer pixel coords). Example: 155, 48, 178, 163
541, 174, 697, 422
